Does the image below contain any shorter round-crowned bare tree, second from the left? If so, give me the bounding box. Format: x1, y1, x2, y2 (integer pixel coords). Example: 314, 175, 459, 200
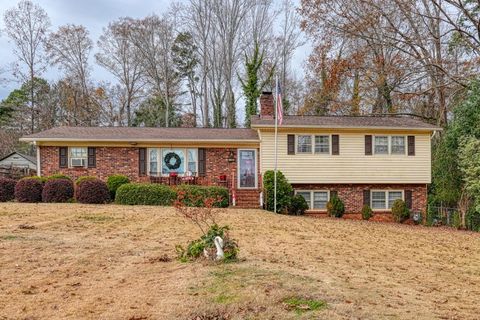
46, 24, 98, 125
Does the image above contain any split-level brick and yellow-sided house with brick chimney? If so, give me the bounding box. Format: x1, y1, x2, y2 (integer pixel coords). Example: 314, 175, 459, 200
21, 93, 441, 213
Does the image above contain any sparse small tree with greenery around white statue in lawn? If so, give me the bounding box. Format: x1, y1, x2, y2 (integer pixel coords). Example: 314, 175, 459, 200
174, 191, 239, 262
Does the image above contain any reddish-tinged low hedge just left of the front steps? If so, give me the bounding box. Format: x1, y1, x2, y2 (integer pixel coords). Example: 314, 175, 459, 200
176, 184, 229, 208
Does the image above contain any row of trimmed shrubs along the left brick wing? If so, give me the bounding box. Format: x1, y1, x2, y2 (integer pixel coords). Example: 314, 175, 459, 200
0, 175, 229, 208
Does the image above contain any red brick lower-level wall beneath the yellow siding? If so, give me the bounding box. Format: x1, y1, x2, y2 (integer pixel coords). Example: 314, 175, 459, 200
293, 184, 427, 213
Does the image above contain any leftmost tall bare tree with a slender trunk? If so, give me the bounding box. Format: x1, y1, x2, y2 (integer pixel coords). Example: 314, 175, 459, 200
4, 0, 50, 133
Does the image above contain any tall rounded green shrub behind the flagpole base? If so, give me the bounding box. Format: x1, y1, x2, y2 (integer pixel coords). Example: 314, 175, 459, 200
263, 170, 293, 212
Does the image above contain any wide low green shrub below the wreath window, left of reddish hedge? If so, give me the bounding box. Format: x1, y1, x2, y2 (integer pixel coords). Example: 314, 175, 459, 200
115, 183, 177, 206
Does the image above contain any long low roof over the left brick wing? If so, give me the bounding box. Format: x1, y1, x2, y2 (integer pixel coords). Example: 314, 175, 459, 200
21, 127, 258, 141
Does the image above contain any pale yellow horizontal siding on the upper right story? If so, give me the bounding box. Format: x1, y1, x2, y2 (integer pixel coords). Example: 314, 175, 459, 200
260, 129, 431, 183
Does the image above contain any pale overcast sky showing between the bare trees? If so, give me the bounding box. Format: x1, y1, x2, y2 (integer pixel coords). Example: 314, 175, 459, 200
0, 0, 309, 99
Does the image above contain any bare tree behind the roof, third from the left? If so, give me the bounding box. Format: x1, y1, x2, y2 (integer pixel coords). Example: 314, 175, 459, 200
95, 18, 144, 126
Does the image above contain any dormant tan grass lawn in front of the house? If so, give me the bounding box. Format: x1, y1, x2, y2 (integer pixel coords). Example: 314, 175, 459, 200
0, 203, 480, 320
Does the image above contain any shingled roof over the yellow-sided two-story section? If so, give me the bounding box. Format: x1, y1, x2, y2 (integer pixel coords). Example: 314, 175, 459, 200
252, 116, 442, 130
